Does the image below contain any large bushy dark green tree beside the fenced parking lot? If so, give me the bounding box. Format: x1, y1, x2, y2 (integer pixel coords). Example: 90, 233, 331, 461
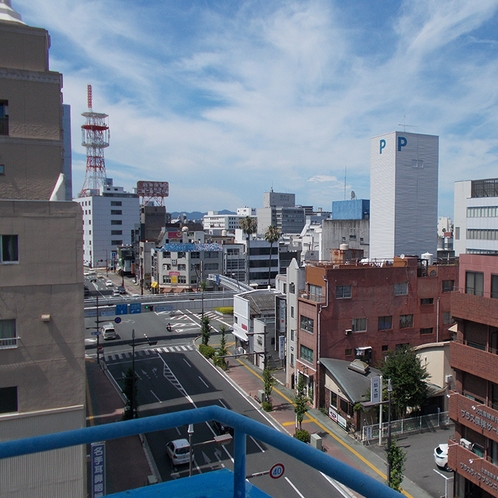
379, 346, 429, 418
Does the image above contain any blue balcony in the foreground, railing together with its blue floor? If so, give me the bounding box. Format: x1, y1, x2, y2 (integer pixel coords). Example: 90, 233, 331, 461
0, 406, 400, 498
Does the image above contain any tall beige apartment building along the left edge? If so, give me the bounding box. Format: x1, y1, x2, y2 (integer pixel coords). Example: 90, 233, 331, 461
0, 0, 86, 498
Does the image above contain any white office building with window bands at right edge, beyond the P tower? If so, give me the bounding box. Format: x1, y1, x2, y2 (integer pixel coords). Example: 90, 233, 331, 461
453, 178, 498, 256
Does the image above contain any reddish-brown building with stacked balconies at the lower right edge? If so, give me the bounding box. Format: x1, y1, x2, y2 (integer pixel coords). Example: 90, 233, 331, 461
448, 254, 498, 498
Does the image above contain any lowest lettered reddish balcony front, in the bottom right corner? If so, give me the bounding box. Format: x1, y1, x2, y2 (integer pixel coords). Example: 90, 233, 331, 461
448, 441, 498, 496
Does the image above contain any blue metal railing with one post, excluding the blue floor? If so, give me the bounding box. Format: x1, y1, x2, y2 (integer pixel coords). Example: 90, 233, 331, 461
0, 406, 400, 498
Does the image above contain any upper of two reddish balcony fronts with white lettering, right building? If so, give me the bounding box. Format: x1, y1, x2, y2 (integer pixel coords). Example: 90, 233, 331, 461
449, 391, 498, 444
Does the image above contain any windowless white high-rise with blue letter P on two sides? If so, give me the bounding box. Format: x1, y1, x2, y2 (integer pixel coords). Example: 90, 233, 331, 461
370, 131, 439, 259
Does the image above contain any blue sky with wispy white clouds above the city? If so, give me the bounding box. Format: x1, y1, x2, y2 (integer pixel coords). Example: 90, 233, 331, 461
12, 0, 498, 216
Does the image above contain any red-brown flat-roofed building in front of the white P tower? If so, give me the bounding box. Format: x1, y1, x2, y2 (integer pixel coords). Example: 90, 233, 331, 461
296, 253, 458, 416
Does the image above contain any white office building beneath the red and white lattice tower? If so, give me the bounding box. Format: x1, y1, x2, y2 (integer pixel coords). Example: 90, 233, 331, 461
75, 179, 140, 267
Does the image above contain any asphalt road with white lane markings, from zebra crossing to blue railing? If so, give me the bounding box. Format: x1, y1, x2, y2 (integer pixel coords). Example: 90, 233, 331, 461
103, 336, 348, 498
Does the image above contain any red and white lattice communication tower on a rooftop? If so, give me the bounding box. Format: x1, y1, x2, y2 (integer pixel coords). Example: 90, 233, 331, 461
80, 85, 110, 197
